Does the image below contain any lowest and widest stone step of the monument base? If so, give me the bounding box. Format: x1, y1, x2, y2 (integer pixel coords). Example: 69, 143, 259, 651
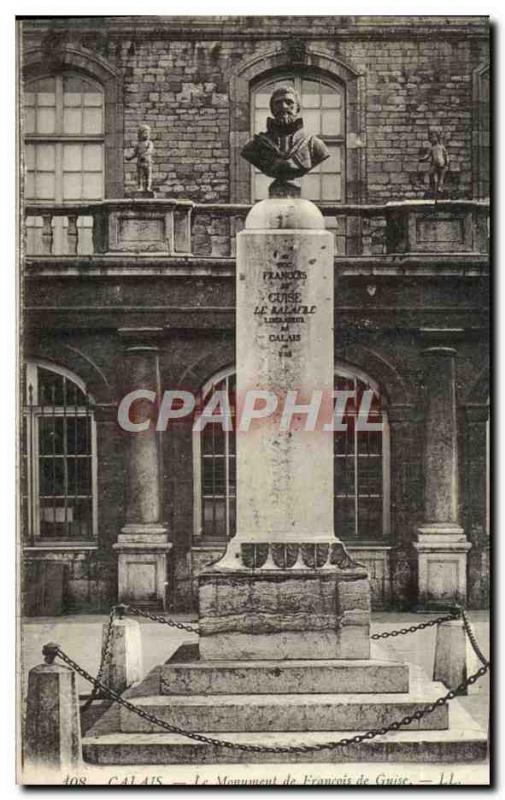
82, 700, 487, 766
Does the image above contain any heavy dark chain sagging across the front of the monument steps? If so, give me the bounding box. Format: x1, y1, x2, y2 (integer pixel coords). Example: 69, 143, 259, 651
56, 648, 490, 753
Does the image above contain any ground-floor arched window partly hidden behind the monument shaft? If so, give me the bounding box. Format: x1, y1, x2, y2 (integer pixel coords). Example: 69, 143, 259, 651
193, 365, 390, 542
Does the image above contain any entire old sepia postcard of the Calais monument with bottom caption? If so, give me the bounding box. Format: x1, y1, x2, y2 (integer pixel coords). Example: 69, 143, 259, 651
17, 16, 490, 788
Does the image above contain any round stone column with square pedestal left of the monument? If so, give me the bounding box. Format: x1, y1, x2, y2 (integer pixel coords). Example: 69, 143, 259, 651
114, 330, 172, 608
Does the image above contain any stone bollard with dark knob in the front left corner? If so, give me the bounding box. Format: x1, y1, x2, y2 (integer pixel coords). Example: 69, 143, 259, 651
24, 642, 82, 770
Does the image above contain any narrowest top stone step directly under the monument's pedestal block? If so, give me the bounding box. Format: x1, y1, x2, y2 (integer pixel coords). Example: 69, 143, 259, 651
159, 660, 409, 695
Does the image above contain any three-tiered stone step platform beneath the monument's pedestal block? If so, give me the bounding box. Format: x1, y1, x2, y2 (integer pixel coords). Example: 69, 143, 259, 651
83, 646, 487, 765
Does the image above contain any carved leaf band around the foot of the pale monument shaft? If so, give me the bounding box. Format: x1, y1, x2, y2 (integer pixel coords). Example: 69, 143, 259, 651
240, 542, 364, 570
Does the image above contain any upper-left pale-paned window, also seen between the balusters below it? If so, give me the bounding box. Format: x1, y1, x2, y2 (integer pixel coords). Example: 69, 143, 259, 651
23, 73, 104, 253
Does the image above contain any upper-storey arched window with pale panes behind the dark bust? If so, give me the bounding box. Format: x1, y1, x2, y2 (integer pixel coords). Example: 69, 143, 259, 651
251, 73, 345, 203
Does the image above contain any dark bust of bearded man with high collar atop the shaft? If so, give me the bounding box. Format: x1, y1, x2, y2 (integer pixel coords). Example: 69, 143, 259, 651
241, 86, 330, 197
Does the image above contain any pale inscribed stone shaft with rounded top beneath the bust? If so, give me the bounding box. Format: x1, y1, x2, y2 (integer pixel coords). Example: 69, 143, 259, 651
234, 199, 334, 545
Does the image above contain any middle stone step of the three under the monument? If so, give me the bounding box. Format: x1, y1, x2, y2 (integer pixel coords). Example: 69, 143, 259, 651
119, 683, 448, 733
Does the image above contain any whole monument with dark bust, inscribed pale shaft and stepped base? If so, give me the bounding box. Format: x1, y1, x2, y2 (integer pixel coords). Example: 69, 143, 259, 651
83, 89, 486, 766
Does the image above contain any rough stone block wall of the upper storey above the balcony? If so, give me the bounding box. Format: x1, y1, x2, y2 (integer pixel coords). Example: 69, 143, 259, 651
21, 17, 489, 202
